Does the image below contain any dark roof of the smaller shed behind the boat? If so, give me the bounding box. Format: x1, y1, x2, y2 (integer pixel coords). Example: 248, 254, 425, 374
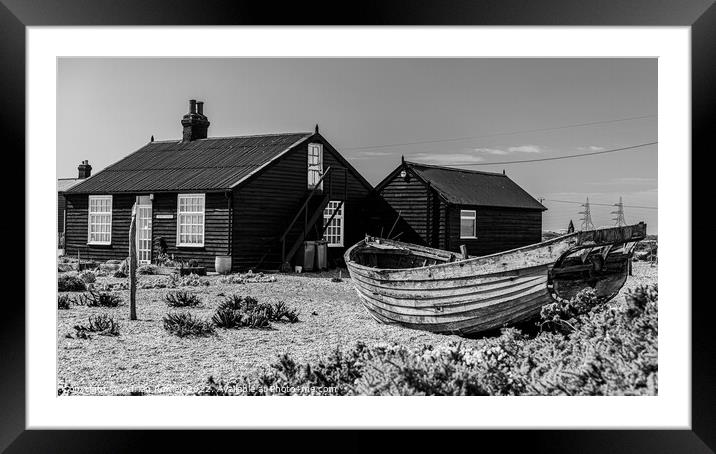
405, 162, 547, 210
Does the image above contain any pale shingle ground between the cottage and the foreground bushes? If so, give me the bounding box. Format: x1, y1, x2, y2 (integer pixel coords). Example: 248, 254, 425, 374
57, 262, 657, 394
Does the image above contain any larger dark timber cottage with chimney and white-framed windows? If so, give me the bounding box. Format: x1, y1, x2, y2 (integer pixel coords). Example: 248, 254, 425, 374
65, 100, 384, 271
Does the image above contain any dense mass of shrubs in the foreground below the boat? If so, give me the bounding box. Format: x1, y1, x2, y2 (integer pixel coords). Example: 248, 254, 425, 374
200, 286, 658, 395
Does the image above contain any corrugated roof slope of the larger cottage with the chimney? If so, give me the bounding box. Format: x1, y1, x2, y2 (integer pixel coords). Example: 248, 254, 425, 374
67, 132, 313, 193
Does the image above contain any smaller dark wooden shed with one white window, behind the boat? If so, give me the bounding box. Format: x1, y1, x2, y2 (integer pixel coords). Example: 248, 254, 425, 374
376, 161, 546, 255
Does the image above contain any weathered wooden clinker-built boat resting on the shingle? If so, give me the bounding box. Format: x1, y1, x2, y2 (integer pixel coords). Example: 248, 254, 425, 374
344, 223, 646, 335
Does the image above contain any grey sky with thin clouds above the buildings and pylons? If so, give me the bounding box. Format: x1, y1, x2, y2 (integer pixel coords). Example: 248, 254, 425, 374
57, 58, 658, 233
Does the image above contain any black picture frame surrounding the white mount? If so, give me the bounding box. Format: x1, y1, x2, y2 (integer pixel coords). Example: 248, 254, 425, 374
0, 0, 716, 453
